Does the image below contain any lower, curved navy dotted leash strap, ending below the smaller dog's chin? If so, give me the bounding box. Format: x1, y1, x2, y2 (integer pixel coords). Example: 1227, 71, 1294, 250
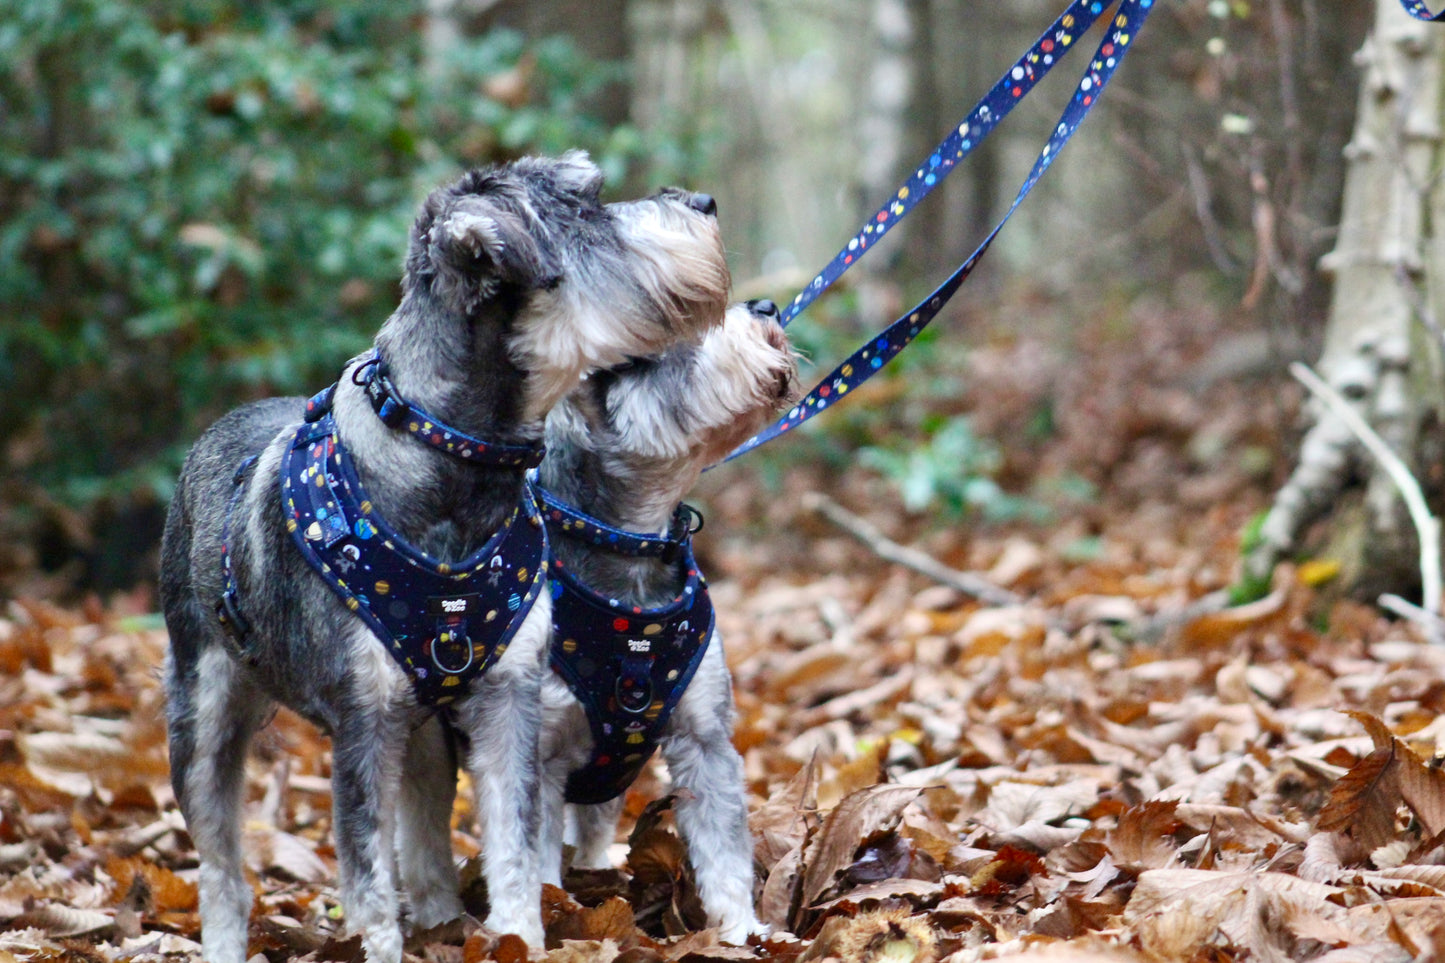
725, 0, 1155, 461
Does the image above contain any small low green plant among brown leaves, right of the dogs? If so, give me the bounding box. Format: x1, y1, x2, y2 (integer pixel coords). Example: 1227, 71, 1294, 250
858, 416, 1046, 522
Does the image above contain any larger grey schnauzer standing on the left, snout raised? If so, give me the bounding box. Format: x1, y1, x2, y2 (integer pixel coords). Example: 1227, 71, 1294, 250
160, 152, 730, 963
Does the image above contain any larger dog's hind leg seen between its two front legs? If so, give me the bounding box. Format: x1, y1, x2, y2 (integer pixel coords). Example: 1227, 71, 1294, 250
396, 717, 462, 930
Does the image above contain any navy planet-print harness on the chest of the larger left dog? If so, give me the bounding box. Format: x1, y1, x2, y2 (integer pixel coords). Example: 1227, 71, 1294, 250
282, 414, 549, 706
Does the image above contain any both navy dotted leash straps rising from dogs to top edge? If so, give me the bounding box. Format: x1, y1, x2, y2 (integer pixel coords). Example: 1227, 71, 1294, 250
725, 0, 1156, 461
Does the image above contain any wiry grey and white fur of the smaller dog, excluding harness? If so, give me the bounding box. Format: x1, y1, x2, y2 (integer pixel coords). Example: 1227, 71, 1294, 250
538, 297, 798, 943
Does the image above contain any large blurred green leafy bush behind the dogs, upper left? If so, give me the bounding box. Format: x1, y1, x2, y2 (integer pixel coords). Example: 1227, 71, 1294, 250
0, 0, 661, 503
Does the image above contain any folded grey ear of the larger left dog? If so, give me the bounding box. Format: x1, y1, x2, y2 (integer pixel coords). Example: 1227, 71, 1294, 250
418, 195, 539, 315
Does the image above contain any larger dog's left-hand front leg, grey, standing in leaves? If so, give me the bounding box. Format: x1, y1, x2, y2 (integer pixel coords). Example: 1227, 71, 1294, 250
331, 632, 409, 963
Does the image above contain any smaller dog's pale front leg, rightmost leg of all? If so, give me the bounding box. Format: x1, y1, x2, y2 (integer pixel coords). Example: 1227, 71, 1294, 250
662, 638, 764, 943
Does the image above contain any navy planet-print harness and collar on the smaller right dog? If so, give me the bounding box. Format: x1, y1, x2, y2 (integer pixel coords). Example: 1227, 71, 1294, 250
538, 489, 714, 804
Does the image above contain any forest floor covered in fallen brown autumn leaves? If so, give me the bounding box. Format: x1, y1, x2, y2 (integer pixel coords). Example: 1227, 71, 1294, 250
0, 289, 1445, 963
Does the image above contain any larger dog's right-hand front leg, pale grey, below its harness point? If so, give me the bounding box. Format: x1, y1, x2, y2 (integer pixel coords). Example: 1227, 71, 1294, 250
457, 593, 552, 949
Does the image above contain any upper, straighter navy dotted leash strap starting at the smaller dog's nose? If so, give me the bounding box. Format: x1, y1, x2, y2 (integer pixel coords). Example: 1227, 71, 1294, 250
782, 0, 1114, 327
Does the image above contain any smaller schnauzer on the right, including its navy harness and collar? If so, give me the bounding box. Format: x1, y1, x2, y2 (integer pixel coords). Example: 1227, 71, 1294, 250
538, 301, 798, 943
